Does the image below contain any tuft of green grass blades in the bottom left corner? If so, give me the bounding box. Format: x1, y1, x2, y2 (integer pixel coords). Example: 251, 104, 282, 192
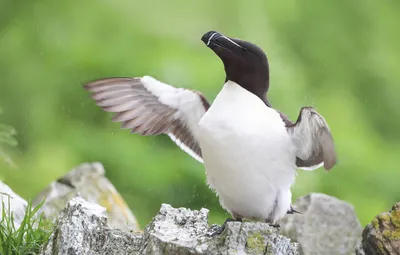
0, 199, 52, 255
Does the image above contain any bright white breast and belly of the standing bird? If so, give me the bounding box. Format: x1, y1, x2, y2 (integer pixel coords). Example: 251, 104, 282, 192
198, 81, 296, 222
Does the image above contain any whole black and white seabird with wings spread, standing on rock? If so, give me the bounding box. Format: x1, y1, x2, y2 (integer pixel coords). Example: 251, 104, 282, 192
84, 31, 336, 227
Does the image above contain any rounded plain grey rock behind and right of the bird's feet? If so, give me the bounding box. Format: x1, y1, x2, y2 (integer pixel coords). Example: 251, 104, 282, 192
280, 193, 362, 255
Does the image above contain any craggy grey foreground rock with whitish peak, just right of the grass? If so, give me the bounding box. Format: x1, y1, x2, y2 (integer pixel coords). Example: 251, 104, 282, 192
42, 197, 142, 255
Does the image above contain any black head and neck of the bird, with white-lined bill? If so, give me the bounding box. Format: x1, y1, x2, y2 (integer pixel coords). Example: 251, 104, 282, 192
201, 31, 270, 106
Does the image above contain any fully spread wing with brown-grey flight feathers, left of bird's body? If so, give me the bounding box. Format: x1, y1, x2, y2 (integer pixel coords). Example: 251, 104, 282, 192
84, 76, 210, 162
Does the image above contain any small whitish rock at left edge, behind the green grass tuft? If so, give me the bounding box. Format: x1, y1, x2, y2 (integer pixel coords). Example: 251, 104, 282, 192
0, 181, 27, 229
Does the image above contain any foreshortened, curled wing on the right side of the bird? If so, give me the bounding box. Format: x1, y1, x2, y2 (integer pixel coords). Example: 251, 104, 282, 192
287, 107, 336, 170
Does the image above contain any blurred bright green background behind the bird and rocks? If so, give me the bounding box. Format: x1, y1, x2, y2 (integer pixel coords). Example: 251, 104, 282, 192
0, 0, 400, 227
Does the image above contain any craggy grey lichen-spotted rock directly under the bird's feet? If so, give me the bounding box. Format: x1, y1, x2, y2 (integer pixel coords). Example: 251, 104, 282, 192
141, 204, 298, 255
